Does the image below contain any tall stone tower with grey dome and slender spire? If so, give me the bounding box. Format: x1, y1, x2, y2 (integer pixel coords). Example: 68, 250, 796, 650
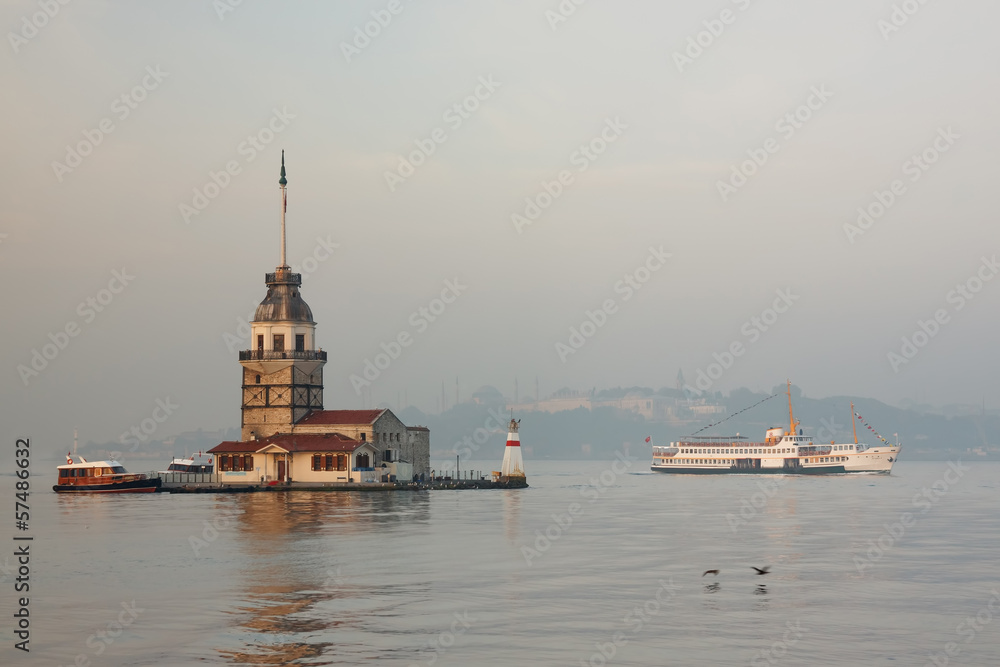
240, 151, 326, 441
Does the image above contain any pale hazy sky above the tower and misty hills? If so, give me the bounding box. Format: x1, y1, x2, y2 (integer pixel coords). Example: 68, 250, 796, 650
0, 0, 1000, 450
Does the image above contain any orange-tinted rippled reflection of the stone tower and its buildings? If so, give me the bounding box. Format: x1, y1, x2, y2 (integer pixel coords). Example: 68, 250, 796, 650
217, 492, 431, 665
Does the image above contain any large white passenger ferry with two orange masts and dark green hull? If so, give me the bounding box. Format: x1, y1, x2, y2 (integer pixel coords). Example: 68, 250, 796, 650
651, 383, 902, 475
